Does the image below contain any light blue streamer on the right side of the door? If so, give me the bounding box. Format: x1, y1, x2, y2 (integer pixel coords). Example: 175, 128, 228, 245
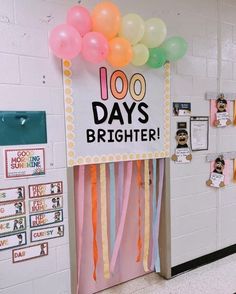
151, 159, 157, 269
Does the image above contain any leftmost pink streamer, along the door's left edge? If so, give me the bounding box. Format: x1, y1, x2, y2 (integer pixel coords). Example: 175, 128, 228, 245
74, 165, 85, 293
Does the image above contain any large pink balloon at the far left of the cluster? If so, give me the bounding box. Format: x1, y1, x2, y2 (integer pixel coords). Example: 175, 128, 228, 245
49, 24, 82, 59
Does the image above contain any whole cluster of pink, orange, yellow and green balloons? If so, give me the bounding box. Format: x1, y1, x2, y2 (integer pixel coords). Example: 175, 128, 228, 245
49, 1, 188, 68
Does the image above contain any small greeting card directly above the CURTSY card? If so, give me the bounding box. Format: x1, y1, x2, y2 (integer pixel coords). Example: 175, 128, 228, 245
30, 209, 63, 228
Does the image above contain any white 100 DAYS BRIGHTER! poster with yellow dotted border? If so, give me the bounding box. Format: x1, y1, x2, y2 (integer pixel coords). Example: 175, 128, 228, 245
63, 58, 170, 166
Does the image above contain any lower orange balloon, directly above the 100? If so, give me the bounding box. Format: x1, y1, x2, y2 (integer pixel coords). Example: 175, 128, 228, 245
107, 38, 133, 67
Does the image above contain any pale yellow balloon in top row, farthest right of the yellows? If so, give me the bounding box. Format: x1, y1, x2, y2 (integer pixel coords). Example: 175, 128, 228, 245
141, 18, 167, 48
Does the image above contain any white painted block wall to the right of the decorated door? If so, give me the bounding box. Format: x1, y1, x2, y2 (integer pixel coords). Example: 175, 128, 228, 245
170, 0, 236, 266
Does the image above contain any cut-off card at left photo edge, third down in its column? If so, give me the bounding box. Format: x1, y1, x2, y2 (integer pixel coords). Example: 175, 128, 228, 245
0, 216, 26, 236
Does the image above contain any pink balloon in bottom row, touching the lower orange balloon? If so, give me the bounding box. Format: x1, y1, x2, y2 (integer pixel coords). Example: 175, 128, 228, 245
82, 32, 109, 63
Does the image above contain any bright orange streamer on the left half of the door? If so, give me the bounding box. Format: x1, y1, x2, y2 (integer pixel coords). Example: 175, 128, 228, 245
90, 164, 98, 281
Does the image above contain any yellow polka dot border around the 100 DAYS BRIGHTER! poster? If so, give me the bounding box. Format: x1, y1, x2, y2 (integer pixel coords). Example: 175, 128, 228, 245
63, 60, 171, 167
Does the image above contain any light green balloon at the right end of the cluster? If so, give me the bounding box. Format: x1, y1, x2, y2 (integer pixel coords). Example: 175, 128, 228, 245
161, 36, 188, 61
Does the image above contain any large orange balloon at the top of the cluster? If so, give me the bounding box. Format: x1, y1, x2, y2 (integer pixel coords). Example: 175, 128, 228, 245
91, 2, 121, 40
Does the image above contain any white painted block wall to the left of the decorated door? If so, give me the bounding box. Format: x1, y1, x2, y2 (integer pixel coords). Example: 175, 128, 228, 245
0, 0, 77, 294
